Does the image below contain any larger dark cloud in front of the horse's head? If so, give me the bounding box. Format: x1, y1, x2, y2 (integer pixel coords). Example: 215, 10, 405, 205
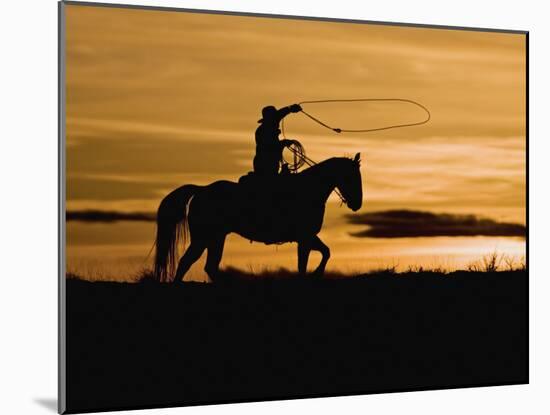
346, 210, 526, 238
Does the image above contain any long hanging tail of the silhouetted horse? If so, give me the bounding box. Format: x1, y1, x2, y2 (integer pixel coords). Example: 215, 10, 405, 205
154, 184, 201, 282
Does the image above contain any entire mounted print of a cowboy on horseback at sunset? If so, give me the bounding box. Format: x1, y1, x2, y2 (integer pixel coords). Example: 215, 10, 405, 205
59, 1, 528, 413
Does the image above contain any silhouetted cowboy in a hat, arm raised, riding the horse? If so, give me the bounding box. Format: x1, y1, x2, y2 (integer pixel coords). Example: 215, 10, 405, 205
253, 104, 302, 176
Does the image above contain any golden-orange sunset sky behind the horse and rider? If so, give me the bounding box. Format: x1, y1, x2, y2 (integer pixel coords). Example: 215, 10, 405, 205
66, 5, 526, 278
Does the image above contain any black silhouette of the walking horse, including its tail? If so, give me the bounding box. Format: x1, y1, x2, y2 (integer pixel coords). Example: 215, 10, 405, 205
154, 153, 363, 282
